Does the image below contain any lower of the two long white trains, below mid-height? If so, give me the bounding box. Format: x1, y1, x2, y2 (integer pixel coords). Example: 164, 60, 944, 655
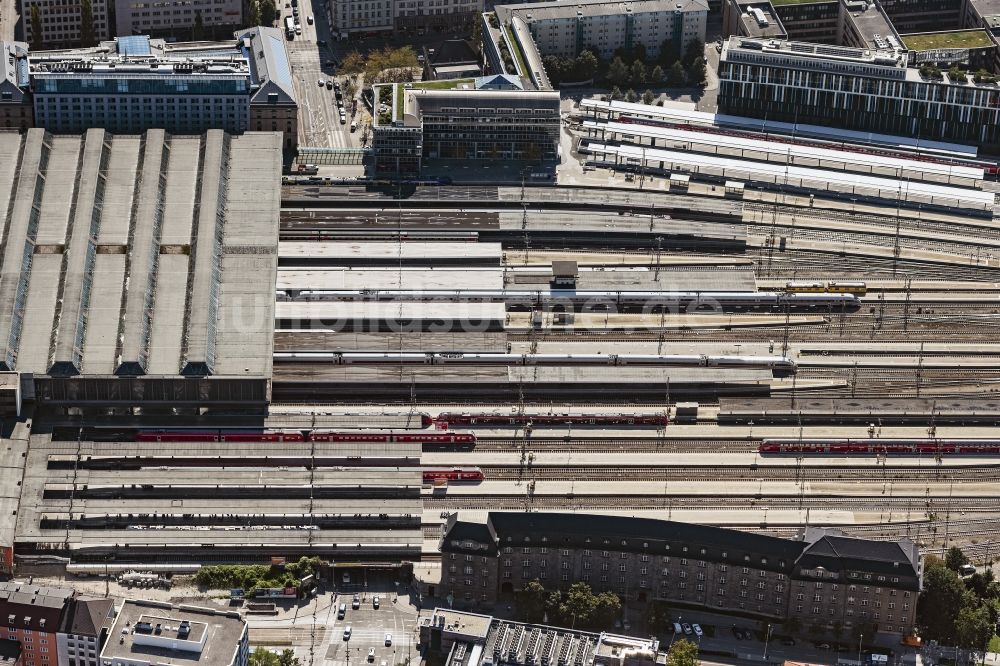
274, 352, 796, 372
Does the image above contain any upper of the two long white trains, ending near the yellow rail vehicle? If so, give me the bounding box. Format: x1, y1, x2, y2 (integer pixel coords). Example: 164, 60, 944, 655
276, 289, 861, 309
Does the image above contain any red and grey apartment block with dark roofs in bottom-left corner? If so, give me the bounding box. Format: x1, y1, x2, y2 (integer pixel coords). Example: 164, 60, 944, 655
0, 582, 114, 666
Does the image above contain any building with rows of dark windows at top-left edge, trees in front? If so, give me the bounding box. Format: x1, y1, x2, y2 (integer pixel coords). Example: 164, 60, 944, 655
20, 0, 110, 49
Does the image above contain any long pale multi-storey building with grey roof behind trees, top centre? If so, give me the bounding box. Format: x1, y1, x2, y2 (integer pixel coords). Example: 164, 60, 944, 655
496, 0, 708, 58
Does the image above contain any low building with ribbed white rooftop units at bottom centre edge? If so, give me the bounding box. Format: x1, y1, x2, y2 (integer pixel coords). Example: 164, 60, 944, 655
419, 608, 660, 666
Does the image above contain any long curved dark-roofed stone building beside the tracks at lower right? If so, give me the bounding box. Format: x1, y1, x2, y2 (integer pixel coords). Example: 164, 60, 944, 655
432, 513, 921, 633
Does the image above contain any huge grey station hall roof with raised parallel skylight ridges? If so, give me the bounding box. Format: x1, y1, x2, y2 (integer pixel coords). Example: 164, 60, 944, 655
0, 129, 281, 381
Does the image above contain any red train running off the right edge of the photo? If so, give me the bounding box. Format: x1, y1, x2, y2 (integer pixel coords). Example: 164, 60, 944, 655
758, 438, 1000, 456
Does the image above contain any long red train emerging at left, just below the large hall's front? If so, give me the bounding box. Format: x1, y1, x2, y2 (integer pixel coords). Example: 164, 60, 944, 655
135, 428, 476, 446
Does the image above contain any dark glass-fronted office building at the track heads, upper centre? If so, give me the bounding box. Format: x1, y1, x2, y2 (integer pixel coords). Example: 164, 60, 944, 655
373, 75, 560, 177
